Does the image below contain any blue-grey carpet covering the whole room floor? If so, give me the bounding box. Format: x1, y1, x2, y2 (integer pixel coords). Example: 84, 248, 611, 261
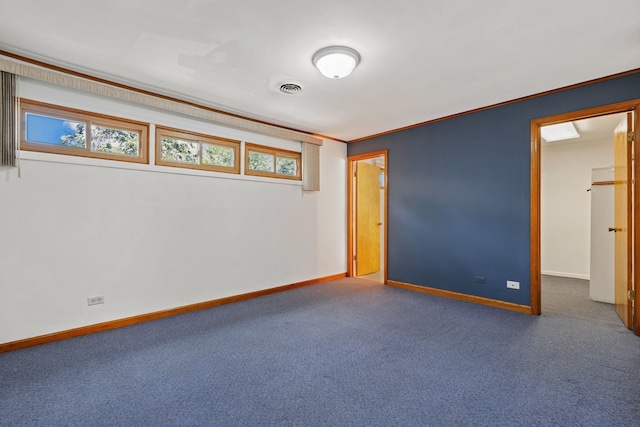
0, 279, 640, 426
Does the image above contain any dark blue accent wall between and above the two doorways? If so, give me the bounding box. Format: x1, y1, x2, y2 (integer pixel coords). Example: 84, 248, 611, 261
347, 73, 640, 305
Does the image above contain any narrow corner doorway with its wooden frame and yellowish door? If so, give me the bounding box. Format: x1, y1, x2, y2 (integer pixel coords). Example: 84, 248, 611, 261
347, 150, 388, 283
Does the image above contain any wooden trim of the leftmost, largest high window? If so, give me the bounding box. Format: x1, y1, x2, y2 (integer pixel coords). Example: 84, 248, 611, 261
20, 99, 149, 163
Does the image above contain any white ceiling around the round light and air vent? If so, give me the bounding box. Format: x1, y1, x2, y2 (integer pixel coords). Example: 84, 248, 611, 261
0, 0, 640, 140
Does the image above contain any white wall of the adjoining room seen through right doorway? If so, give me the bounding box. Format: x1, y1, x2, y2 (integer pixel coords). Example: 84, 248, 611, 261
541, 137, 613, 280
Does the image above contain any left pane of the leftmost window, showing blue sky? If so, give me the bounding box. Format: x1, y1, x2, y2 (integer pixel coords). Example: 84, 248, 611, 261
26, 113, 87, 148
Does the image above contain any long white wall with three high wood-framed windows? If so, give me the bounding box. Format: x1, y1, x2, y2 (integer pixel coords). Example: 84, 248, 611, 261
0, 79, 347, 343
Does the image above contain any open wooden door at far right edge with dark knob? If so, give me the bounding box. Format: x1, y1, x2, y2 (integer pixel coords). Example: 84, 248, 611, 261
610, 113, 633, 328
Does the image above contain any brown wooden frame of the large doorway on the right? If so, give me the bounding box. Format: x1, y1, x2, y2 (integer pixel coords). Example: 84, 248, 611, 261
530, 99, 640, 336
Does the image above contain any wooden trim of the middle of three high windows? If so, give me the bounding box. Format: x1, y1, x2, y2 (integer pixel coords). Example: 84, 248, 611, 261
155, 126, 240, 174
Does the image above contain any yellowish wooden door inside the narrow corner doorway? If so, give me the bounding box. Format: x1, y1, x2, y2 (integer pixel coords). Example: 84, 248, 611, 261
356, 162, 382, 276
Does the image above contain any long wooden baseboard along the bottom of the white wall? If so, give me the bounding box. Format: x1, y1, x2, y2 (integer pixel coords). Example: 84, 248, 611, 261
0, 273, 347, 354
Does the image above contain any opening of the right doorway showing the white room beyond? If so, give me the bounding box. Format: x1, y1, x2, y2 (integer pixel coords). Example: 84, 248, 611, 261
540, 113, 627, 323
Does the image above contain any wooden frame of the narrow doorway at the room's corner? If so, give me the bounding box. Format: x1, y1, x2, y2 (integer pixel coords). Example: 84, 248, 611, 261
347, 150, 389, 285
